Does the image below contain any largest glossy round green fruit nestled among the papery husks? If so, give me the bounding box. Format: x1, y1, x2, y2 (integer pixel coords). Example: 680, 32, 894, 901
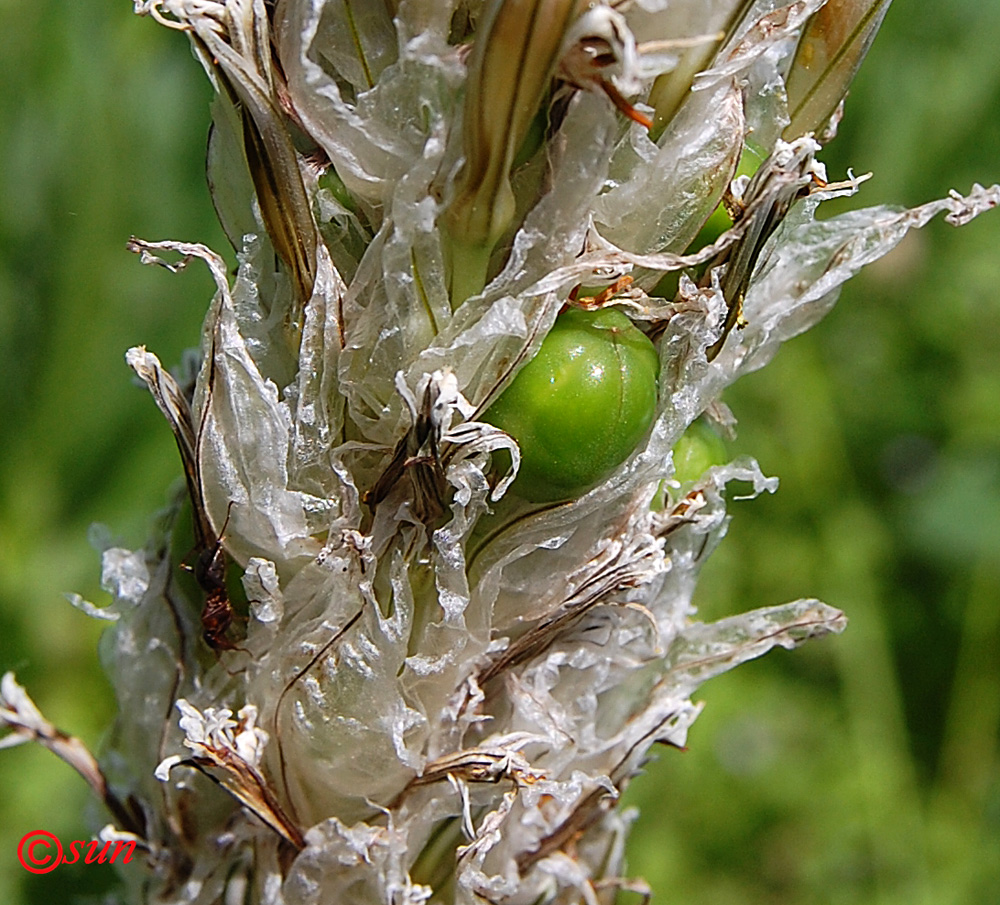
483, 308, 660, 502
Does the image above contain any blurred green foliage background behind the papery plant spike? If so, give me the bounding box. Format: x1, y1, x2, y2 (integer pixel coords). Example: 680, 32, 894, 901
0, 0, 1000, 905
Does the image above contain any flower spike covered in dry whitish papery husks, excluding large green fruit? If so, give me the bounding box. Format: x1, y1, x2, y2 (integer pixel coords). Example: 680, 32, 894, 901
0, 0, 1000, 905
